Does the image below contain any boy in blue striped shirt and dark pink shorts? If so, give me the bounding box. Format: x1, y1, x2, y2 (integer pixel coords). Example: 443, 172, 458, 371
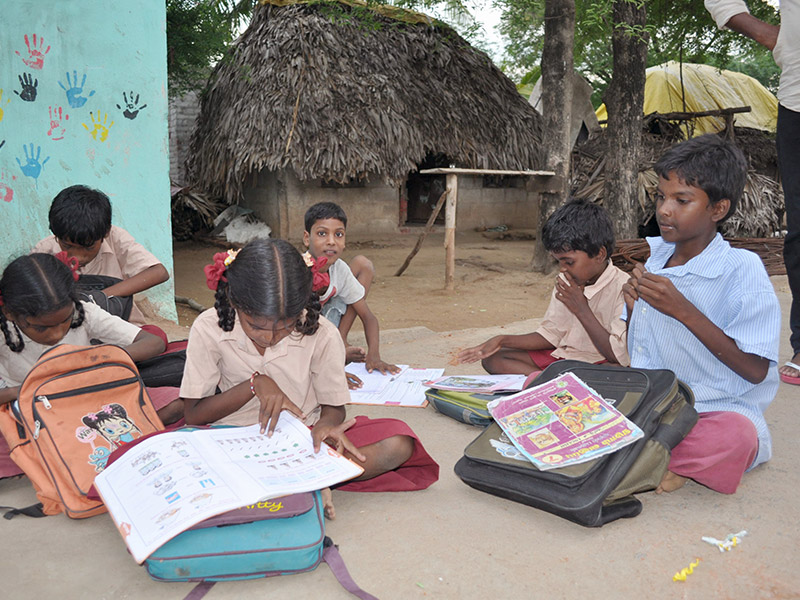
624, 134, 781, 494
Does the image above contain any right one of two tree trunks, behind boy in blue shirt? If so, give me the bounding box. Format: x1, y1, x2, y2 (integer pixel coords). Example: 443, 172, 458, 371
603, 0, 648, 239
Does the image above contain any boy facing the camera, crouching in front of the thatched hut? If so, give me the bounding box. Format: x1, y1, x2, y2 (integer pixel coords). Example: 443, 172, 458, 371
303, 202, 400, 374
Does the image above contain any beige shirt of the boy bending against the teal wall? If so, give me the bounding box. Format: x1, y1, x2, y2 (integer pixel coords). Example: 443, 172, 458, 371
32, 225, 161, 325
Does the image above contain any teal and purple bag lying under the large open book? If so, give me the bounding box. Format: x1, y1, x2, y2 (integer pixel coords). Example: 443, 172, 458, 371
144, 491, 376, 600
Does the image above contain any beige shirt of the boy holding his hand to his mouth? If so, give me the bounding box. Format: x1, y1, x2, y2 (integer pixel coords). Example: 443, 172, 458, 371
536, 263, 630, 366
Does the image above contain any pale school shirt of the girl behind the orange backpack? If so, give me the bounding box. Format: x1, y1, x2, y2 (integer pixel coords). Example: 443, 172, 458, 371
0, 302, 141, 387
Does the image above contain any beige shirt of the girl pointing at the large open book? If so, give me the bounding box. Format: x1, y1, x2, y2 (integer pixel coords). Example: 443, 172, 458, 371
181, 308, 350, 426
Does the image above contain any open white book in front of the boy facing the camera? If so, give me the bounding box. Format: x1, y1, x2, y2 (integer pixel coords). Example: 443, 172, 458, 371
345, 363, 444, 407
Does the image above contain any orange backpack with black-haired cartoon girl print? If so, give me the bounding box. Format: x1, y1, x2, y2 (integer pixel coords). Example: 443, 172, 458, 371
0, 344, 164, 519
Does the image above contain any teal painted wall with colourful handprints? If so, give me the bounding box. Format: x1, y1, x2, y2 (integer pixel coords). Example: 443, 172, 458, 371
0, 0, 176, 320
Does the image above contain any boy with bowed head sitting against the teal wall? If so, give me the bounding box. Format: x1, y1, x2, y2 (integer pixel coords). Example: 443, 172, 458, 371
33, 185, 169, 342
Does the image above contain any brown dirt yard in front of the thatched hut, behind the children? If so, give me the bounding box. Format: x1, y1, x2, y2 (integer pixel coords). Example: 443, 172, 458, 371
173, 232, 555, 332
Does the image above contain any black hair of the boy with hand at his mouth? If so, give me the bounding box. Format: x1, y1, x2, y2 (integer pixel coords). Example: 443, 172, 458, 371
542, 200, 614, 258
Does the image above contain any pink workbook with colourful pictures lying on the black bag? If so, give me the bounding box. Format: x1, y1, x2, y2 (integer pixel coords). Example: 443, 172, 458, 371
487, 373, 643, 471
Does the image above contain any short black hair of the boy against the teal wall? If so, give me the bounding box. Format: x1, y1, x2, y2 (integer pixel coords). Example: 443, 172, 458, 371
50, 185, 111, 246
